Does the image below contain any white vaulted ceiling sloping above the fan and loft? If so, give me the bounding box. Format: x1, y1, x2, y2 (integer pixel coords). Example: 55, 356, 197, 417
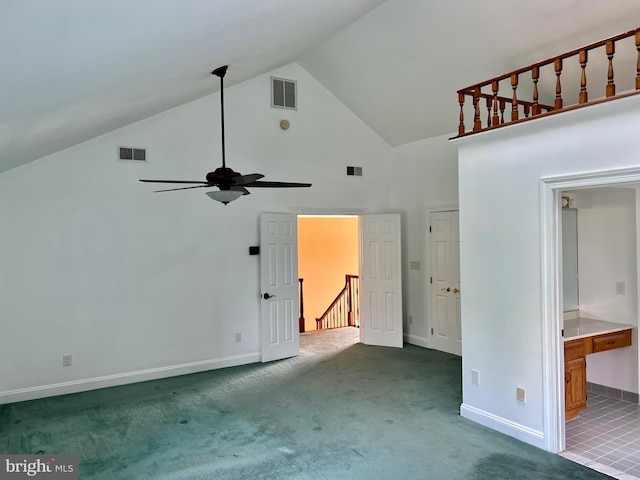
0, 0, 640, 172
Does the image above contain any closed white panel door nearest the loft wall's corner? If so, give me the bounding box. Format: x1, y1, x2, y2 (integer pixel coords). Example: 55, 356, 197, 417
431, 211, 462, 355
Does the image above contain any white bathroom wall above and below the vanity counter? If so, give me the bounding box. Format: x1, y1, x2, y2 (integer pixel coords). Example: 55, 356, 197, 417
572, 187, 638, 393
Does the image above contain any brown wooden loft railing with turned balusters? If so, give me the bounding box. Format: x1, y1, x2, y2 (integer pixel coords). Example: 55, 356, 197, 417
458, 28, 640, 137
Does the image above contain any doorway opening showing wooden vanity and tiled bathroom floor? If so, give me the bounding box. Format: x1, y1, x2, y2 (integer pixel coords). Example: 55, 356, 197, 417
561, 185, 640, 477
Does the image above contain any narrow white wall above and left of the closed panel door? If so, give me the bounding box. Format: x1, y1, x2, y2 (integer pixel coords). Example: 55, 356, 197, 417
392, 134, 458, 347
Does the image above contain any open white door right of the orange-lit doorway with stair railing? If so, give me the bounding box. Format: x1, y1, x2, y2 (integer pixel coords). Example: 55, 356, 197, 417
360, 214, 403, 348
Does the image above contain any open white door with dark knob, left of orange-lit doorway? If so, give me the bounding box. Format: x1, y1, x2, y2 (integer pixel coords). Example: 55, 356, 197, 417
260, 213, 300, 362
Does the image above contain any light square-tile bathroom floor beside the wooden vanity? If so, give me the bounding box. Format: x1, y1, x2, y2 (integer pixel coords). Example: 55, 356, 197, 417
563, 393, 640, 480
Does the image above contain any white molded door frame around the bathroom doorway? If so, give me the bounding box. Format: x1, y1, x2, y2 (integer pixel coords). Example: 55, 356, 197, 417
540, 168, 640, 453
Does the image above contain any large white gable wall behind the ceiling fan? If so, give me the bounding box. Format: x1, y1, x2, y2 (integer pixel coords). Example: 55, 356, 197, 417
0, 64, 392, 403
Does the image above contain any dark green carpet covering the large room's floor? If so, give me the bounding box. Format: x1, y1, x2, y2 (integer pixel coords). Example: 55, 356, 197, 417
0, 329, 610, 480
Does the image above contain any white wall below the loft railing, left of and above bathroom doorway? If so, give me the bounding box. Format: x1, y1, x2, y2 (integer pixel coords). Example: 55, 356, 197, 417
456, 96, 640, 447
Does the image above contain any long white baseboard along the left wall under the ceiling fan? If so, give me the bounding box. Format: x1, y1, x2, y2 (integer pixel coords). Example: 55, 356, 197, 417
0, 353, 260, 405
